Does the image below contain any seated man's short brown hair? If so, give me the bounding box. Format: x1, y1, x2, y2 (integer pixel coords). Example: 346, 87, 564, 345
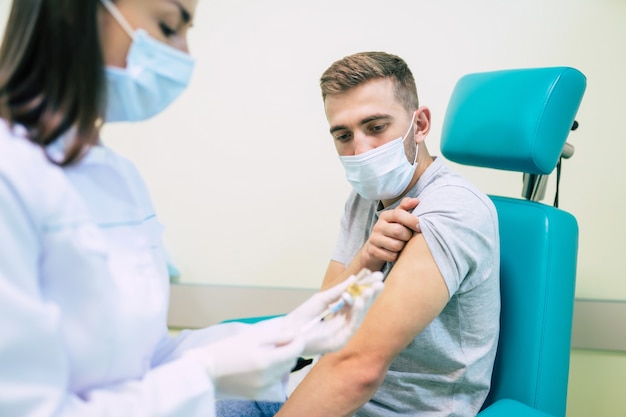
320, 52, 419, 112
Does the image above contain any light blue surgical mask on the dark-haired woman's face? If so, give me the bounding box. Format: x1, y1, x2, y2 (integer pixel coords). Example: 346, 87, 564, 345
100, 0, 194, 122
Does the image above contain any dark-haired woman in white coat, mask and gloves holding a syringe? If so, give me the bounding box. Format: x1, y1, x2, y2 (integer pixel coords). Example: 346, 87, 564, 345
0, 0, 382, 417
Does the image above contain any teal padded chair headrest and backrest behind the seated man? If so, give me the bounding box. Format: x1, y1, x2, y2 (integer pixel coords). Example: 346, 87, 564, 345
441, 67, 586, 416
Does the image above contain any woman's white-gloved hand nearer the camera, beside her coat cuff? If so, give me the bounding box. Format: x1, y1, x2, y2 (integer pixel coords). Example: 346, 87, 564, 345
185, 323, 305, 401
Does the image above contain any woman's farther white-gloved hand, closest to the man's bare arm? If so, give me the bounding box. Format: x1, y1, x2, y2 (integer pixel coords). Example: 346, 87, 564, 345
283, 271, 383, 356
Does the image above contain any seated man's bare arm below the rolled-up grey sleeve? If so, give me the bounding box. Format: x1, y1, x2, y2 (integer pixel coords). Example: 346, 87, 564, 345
277, 234, 449, 417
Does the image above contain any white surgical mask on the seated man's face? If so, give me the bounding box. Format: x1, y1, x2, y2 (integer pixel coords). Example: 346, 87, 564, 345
339, 113, 417, 200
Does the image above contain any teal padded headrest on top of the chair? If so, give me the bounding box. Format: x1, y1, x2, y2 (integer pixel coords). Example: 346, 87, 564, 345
441, 67, 587, 174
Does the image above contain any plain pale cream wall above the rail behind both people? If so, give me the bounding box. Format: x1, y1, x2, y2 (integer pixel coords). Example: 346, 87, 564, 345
0, 0, 626, 299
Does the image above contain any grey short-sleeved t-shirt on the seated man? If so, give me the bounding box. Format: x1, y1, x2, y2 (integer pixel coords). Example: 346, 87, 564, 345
332, 158, 500, 417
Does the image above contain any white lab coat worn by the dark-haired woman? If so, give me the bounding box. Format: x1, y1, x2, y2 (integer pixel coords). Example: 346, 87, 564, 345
0, 120, 247, 417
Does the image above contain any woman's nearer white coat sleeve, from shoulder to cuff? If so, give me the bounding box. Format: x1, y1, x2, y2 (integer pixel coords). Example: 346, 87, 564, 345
0, 176, 222, 417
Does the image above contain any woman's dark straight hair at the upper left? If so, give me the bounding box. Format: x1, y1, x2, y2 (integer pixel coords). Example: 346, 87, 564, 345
0, 0, 105, 166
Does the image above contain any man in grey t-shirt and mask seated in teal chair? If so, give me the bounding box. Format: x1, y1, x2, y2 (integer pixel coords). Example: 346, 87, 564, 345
217, 52, 500, 417
